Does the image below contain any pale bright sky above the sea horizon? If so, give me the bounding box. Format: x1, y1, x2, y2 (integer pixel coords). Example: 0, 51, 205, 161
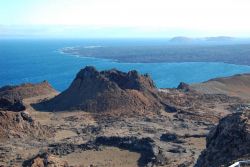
0, 0, 250, 38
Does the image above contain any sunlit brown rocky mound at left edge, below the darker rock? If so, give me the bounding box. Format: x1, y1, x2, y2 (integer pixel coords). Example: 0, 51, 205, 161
0, 111, 52, 140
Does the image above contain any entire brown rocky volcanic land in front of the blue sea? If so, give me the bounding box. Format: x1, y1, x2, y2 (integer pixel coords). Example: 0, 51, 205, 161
0, 67, 250, 167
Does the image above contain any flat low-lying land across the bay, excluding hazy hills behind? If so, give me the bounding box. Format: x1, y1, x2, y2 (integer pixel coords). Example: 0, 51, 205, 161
59, 44, 250, 66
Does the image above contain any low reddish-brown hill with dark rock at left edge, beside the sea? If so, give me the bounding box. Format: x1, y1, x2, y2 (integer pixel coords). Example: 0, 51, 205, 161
0, 81, 56, 111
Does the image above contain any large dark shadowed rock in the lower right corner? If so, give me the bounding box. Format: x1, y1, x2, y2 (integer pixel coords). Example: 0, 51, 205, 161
196, 111, 250, 167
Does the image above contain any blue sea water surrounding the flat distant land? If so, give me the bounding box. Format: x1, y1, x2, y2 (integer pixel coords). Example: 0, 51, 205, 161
0, 39, 250, 91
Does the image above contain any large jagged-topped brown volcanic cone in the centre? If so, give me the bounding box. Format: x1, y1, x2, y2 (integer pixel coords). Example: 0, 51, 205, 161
43, 66, 161, 112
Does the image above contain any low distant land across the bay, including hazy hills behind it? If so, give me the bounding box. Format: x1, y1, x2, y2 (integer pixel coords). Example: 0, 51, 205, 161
61, 36, 250, 65
